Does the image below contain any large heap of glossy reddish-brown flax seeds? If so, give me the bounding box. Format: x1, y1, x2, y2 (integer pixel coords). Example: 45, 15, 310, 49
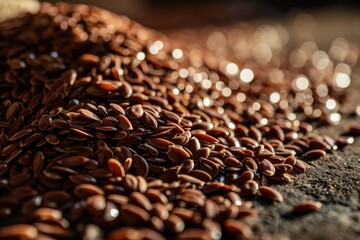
0, 3, 359, 240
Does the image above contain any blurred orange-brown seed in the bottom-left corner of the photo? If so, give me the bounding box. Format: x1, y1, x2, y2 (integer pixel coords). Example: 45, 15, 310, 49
0, 224, 38, 239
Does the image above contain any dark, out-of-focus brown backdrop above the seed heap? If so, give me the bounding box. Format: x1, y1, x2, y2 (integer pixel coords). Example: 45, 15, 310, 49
40, 0, 360, 29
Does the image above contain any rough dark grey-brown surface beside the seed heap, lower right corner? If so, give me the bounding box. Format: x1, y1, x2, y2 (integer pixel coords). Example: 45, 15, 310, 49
255, 125, 360, 240
